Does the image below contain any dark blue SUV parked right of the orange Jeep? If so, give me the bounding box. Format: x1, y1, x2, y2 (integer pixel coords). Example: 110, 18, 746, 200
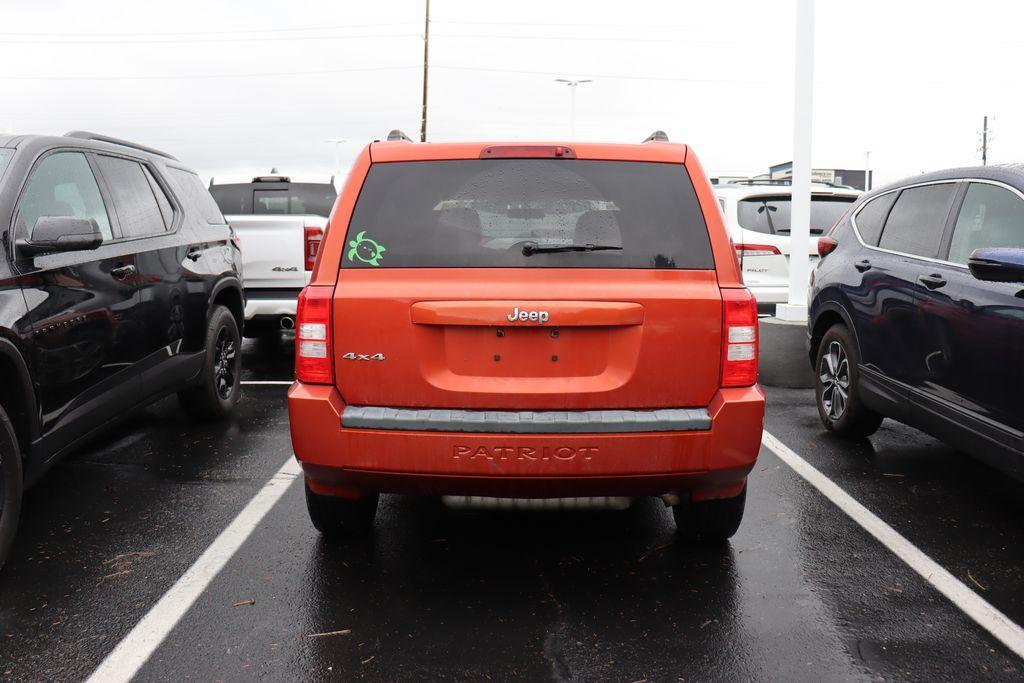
808, 166, 1024, 478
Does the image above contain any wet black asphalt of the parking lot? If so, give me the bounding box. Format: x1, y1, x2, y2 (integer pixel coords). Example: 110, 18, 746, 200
0, 342, 1024, 681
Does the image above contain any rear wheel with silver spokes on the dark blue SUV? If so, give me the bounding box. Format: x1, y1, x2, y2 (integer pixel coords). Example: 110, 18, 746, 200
814, 325, 884, 439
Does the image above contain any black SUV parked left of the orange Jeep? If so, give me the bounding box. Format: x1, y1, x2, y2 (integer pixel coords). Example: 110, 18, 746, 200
0, 132, 244, 566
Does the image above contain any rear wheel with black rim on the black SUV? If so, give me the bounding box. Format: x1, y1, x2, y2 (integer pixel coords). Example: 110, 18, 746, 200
178, 305, 242, 420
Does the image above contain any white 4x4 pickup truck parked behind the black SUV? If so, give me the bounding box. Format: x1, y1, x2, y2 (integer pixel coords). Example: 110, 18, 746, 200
210, 175, 338, 337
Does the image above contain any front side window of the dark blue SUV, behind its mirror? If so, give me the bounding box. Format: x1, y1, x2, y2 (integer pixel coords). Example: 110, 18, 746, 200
949, 182, 1024, 264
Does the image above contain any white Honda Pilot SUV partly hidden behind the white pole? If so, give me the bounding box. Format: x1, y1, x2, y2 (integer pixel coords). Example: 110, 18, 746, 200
715, 180, 860, 312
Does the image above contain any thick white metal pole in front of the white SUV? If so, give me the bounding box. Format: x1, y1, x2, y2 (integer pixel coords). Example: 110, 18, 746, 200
775, 0, 814, 322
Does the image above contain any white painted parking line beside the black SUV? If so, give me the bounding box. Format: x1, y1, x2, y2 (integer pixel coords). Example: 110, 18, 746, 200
88, 458, 301, 683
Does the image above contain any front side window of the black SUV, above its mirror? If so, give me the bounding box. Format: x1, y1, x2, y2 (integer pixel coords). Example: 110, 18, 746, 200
17, 152, 113, 240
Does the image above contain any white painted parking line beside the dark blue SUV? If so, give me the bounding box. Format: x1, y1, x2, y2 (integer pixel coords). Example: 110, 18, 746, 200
761, 432, 1024, 658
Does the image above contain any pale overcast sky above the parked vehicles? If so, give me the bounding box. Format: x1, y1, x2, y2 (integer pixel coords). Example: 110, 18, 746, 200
0, 0, 1024, 181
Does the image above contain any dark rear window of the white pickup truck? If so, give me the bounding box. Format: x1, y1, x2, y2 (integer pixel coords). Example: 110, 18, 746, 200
210, 182, 338, 217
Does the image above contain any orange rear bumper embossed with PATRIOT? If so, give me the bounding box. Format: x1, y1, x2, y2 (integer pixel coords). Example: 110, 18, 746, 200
288, 382, 765, 498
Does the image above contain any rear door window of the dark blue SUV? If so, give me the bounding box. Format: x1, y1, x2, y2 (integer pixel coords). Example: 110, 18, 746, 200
879, 182, 955, 258
